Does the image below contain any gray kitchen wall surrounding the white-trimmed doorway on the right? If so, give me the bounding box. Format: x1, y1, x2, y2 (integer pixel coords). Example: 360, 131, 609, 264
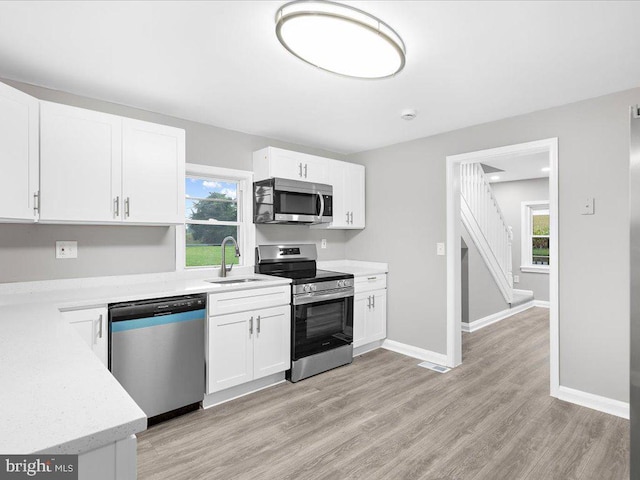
346, 89, 640, 401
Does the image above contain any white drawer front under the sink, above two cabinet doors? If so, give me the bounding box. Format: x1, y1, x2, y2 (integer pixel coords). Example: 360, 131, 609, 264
208, 285, 291, 316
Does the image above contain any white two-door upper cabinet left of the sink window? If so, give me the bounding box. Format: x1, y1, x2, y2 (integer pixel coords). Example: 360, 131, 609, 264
40, 102, 185, 224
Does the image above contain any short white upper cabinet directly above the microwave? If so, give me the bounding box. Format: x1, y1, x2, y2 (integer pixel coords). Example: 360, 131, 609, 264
253, 147, 330, 184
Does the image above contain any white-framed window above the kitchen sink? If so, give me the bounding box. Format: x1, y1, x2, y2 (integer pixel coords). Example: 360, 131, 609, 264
176, 164, 255, 268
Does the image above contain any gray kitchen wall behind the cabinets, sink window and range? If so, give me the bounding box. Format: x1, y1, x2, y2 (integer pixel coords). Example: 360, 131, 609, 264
0, 80, 345, 283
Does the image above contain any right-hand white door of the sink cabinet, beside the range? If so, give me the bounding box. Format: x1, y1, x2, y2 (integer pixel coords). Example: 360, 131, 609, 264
253, 305, 291, 379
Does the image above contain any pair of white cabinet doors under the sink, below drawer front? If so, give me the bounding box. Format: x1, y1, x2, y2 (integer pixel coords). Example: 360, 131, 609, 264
206, 300, 291, 394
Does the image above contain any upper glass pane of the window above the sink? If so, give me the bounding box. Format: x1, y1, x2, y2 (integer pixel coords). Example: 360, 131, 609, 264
185, 177, 238, 222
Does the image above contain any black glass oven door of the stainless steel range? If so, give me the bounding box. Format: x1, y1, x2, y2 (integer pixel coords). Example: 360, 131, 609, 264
291, 289, 353, 360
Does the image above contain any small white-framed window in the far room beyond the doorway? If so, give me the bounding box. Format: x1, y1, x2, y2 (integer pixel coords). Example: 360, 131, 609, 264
520, 200, 550, 273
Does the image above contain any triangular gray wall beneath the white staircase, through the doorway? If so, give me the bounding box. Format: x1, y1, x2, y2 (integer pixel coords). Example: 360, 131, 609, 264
461, 225, 509, 322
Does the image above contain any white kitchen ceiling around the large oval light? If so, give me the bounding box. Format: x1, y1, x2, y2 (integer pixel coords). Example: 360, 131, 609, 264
0, 0, 640, 153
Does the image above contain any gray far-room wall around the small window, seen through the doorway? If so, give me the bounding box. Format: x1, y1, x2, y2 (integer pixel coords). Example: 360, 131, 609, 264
491, 178, 549, 301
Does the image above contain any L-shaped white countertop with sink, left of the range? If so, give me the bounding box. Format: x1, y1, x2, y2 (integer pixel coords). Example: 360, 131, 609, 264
0, 269, 290, 454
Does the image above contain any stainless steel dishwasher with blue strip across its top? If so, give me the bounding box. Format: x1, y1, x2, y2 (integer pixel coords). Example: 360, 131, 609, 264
109, 295, 206, 425
